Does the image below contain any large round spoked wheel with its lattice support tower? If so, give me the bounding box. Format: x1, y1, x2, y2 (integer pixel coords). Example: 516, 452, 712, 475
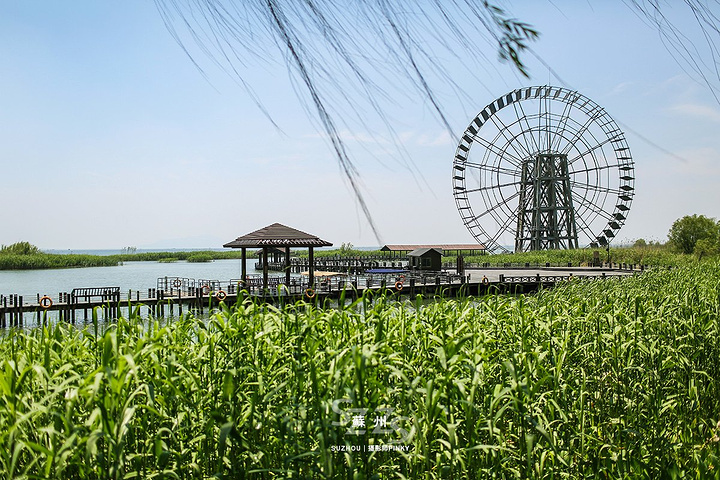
452, 86, 635, 252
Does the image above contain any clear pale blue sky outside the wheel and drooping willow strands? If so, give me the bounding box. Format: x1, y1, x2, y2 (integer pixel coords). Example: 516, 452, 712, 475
0, 0, 720, 249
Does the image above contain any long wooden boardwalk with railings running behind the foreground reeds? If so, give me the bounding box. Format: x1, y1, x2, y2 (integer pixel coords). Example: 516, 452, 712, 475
0, 266, 641, 328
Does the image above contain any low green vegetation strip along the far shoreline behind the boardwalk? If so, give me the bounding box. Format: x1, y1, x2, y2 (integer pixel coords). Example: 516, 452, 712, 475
0, 242, 710, 270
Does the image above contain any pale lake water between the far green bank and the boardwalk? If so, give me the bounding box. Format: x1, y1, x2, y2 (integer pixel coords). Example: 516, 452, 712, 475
0, 258, 258, 303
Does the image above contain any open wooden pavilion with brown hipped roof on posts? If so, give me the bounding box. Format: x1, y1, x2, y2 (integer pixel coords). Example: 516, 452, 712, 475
223, 223, 332, 290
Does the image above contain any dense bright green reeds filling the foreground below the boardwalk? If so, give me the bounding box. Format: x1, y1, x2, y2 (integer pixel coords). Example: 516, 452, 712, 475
0, 262, 720, 479
